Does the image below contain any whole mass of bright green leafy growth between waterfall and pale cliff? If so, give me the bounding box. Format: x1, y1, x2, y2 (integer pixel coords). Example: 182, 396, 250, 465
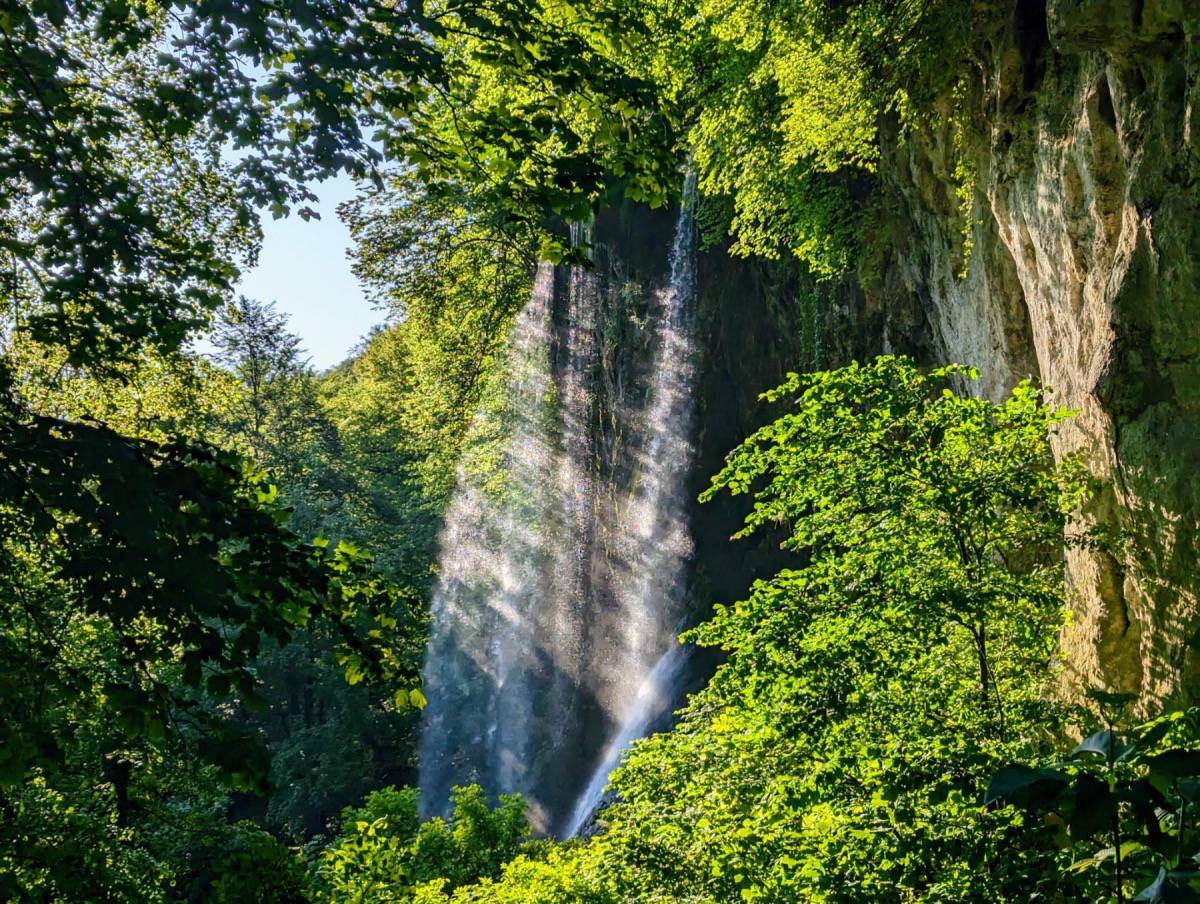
598, 358, 1082, 900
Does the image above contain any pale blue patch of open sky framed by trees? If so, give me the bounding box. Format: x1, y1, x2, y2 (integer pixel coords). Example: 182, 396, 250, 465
236, 175, 384, 370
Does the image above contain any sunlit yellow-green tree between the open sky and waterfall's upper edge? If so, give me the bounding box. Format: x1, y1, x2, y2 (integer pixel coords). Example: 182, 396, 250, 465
338, 176, 539, 501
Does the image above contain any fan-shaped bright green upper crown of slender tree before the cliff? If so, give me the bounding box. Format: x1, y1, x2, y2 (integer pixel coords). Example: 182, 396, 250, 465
703, 358, 1082, 734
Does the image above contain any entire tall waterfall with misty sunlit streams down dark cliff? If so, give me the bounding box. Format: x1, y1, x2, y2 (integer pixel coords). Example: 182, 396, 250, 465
420, 178, 696, 833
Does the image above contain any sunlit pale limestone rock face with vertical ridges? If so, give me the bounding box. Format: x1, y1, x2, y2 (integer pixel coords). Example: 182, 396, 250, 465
864, 0, 1200, 711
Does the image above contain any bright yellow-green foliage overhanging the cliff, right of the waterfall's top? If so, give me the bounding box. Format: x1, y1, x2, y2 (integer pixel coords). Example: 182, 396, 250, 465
652, 0, 970, 277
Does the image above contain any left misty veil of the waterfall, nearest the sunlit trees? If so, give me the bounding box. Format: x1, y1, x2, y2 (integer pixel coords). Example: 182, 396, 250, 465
420, 264, 557, 815
